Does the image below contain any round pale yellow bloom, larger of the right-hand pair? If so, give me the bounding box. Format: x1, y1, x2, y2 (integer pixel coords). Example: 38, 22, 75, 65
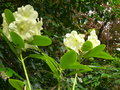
64, 31, 85, 54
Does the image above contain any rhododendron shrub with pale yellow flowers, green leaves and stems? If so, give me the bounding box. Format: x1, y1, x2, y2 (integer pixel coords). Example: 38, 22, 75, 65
0, 5, 114, 90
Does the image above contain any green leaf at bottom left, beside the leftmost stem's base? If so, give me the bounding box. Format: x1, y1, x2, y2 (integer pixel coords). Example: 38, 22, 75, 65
8, 79, 25, 90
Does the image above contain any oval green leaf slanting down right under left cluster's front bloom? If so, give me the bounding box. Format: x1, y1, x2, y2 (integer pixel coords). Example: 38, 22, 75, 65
10, 31, 25, 48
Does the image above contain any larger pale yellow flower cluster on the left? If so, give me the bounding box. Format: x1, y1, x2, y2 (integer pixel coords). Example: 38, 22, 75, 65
2, 5, 43, 48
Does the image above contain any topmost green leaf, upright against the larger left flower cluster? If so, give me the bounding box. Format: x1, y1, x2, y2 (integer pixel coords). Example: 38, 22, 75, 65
4, 9, 15, 25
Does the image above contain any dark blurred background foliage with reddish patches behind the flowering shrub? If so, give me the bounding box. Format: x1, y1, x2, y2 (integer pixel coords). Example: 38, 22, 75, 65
0, 0, 120, 90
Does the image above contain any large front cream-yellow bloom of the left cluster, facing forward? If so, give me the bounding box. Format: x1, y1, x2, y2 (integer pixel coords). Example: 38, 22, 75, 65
9, 20, 42, 40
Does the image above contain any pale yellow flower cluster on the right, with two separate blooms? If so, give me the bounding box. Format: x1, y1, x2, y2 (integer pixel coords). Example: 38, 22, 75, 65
63, 29, 100, 54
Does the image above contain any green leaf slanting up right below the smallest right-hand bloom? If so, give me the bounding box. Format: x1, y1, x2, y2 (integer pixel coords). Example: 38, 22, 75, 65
84, 44, 105, 58
